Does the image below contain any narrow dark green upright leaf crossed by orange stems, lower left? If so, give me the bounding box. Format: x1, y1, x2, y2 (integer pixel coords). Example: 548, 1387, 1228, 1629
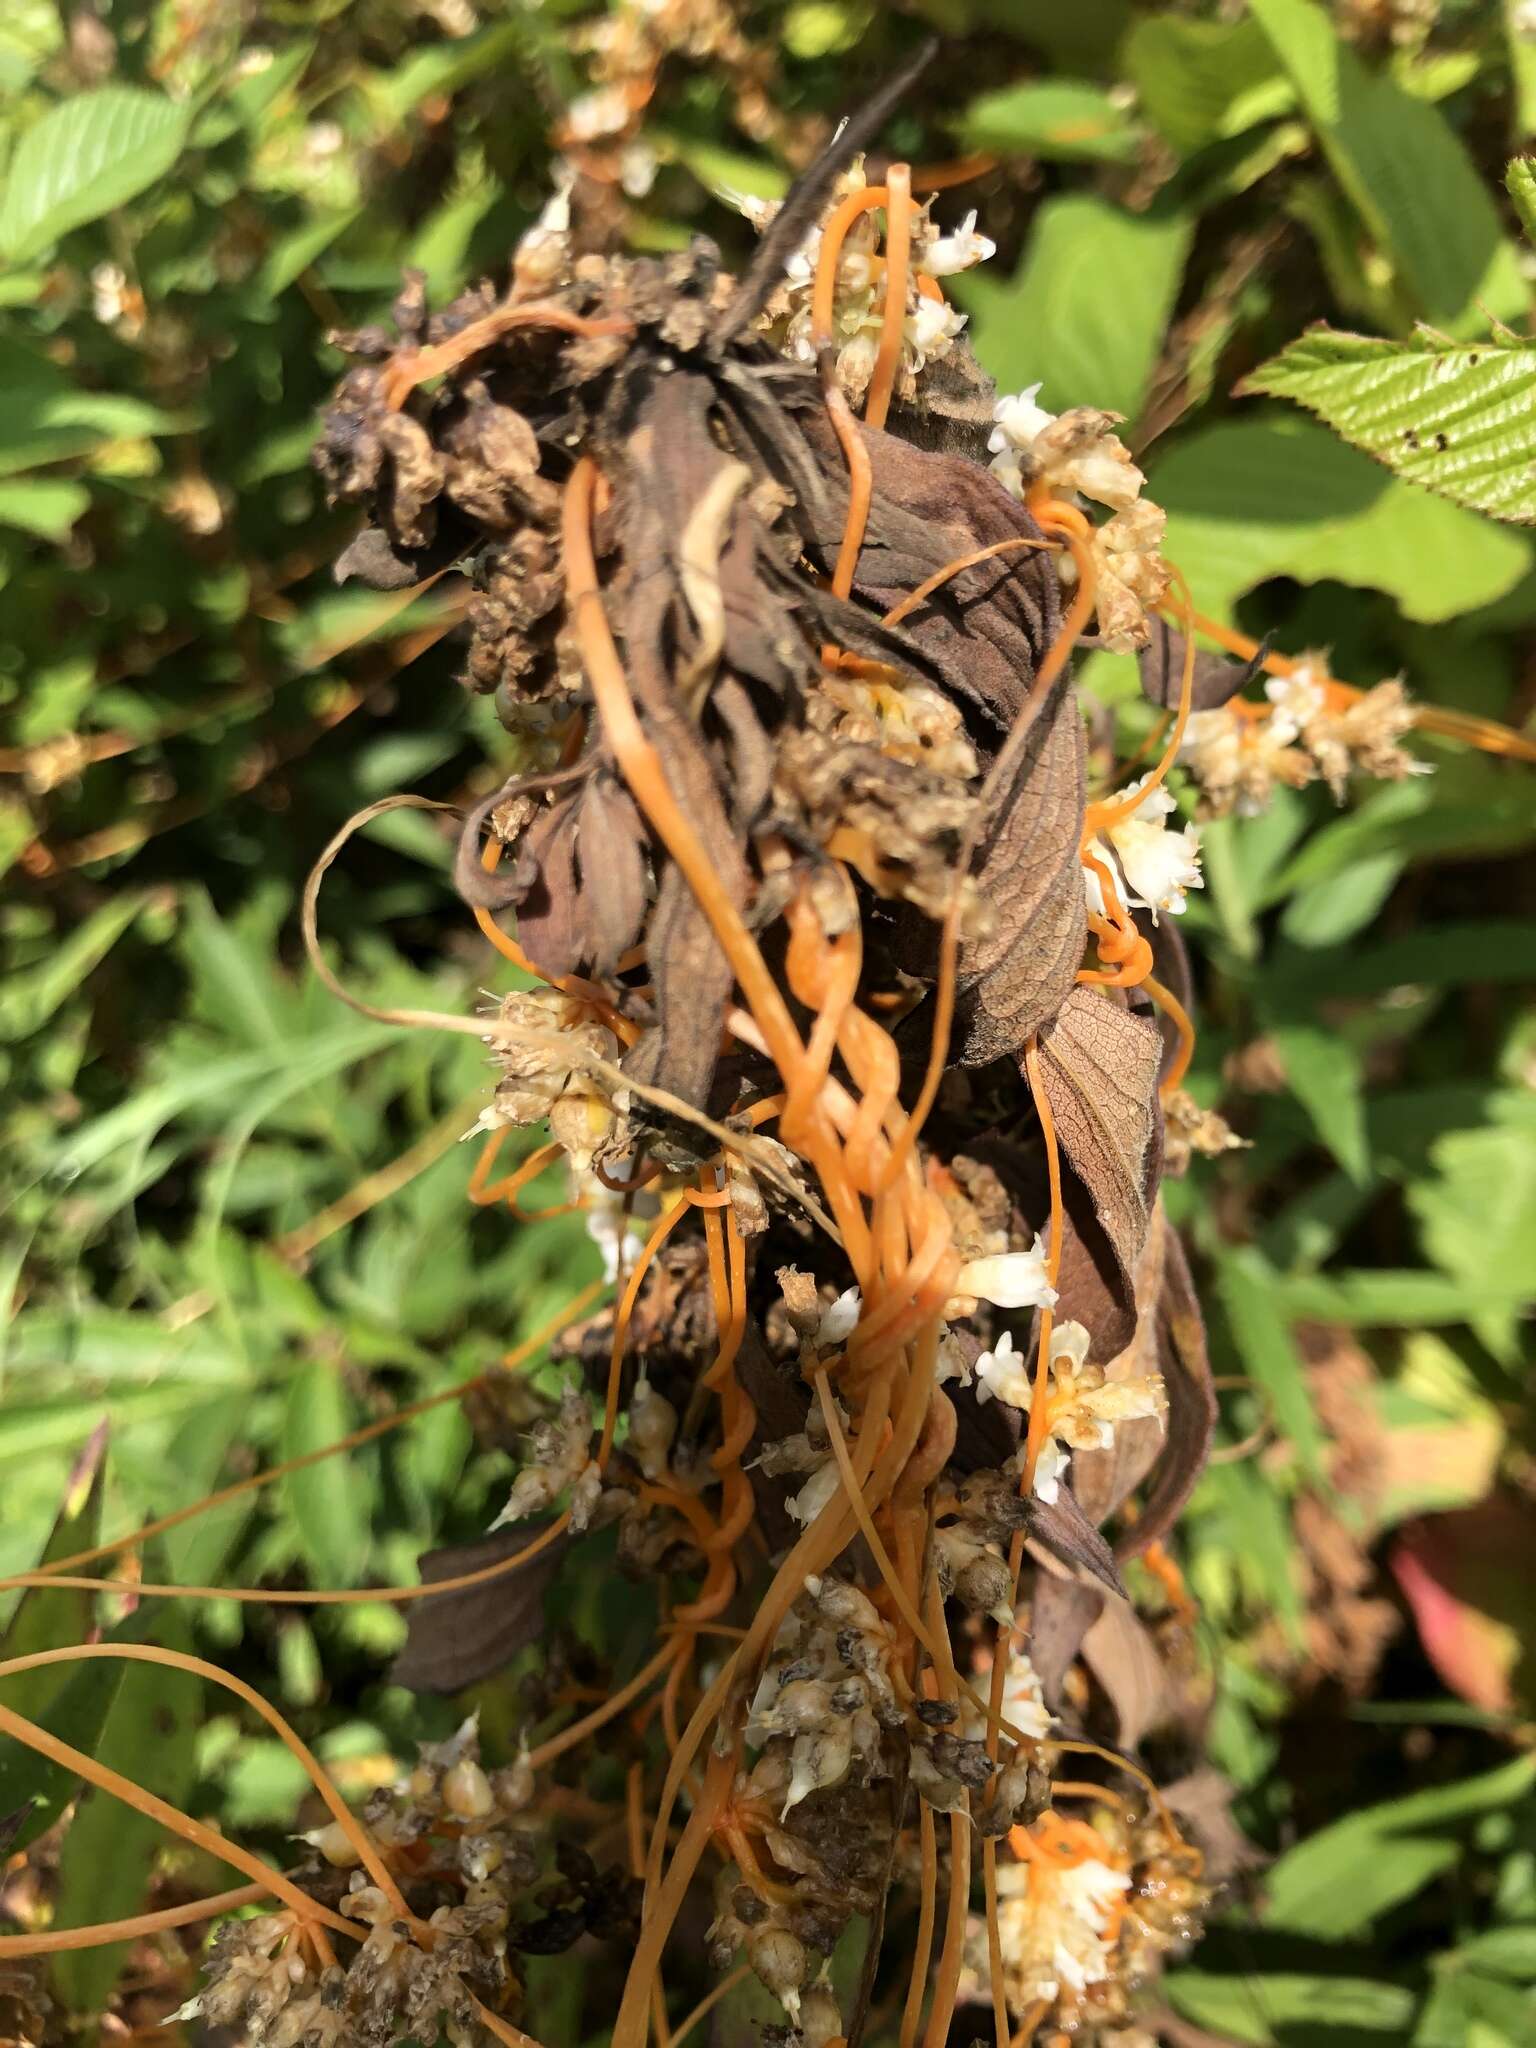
53, 1614, 203, 2013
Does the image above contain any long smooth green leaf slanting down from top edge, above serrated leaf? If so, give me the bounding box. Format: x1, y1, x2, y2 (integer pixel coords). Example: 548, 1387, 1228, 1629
1251, 0, 1526, 332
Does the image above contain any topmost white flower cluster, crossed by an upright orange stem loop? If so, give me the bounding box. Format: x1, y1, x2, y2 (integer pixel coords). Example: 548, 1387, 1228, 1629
749, 158, 995, 403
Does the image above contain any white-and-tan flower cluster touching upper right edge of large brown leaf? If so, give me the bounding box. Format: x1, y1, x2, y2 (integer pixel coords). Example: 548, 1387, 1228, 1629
987, 383, 1169, 653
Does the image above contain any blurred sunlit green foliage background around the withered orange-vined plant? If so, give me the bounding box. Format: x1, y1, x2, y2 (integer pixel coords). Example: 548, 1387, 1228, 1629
0, 0, 1536, 2048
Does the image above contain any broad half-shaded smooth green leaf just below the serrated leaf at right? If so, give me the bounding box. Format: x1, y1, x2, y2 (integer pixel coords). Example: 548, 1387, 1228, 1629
1146, 415, 1530, 623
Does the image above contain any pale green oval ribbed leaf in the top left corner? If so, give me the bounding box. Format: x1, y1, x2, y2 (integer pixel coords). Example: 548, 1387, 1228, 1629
0, 86, 188, 262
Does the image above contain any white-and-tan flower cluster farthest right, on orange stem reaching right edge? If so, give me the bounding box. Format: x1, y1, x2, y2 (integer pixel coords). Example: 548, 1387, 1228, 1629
1182, 657, 1430, 817
